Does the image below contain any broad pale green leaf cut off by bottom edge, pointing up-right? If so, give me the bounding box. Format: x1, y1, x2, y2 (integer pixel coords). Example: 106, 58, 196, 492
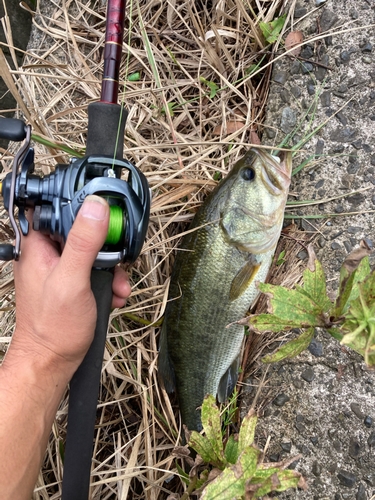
201, 446, 260, 500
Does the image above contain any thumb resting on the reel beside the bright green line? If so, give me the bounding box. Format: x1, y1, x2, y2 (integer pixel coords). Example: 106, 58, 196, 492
59, 195, 109, 281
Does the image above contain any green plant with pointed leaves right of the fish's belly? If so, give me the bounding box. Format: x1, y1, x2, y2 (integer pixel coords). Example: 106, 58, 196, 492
241, 242, 375, 367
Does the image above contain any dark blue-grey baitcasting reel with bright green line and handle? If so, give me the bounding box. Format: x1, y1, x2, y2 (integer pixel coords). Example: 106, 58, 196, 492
0, 118, 150, 268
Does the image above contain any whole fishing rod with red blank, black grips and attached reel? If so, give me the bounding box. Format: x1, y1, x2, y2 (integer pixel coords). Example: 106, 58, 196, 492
0, 0, 150, 500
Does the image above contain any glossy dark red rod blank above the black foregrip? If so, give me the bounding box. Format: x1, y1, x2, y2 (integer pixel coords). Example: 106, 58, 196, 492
100, 0, 126, 104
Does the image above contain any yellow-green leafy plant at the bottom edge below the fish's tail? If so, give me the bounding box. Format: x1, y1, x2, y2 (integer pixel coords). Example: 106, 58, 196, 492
178, 396, 306, 500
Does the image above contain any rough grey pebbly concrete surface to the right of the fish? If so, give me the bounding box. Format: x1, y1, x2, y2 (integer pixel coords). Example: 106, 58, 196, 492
250, 0, 375, 500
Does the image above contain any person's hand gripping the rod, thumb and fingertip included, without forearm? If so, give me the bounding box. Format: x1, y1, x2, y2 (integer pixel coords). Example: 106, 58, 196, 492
9, 196, 131, 375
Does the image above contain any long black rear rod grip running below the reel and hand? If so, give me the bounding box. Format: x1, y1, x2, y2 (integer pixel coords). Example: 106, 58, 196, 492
61, 270, 113, 500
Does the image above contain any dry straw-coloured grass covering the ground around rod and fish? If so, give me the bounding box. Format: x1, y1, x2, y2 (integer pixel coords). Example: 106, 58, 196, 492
0, 0, 322, 500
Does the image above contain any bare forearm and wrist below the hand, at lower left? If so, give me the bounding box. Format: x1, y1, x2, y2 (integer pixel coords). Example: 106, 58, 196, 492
0, 330, 70, 499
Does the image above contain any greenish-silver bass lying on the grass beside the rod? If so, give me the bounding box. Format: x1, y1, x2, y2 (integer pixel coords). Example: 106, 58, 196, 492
158, 148, 292, 431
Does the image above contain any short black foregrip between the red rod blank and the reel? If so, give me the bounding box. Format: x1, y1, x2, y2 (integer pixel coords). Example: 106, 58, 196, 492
86, 102, 128, 160
